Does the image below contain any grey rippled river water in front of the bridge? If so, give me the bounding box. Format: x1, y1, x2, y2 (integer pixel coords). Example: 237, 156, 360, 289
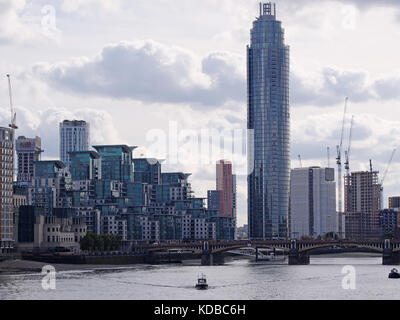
0, 254, 400, 300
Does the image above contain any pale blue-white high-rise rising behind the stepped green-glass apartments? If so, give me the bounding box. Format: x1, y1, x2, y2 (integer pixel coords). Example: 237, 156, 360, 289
60, 120, 90, 167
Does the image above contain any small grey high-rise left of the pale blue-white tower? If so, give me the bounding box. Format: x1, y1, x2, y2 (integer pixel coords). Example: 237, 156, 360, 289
15, 136, 43, 185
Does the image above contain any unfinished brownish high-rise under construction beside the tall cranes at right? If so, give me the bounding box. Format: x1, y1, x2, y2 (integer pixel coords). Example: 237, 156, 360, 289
344, 171, 381, 239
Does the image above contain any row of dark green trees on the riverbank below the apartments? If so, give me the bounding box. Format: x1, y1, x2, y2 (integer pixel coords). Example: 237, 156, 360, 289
80, 232, 122, 251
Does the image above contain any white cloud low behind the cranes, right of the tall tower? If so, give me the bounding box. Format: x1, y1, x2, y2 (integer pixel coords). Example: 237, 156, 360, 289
292, 113, 400, 163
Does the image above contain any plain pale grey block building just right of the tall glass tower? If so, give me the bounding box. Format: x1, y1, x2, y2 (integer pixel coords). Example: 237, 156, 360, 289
289, 167, 338, 239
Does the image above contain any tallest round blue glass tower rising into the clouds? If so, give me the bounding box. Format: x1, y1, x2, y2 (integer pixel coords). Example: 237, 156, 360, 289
247, 3, 290, 239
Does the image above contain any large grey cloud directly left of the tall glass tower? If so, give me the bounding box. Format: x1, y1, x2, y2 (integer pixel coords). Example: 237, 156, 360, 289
34, 40, 246, 105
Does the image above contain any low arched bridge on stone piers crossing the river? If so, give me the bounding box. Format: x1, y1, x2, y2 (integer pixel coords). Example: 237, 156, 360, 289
133, 239, 400, 265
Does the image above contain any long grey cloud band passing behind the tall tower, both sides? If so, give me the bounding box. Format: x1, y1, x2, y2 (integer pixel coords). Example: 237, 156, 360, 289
33, 40, 400, 109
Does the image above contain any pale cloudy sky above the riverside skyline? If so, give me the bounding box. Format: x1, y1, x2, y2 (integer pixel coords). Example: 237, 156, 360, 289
0, 0, 400, 225
